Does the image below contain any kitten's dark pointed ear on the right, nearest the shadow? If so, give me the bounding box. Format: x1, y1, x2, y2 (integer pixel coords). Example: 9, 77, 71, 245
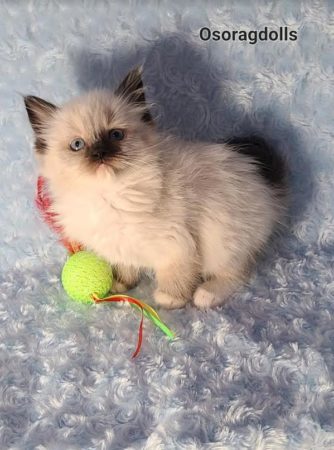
115, 66, 153, 122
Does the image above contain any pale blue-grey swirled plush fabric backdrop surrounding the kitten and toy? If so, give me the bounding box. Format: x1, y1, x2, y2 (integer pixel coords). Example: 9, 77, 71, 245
0, 0, 334, 450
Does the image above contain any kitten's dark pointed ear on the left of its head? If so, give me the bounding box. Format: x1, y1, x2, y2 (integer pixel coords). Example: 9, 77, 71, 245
24, 95, 57, 135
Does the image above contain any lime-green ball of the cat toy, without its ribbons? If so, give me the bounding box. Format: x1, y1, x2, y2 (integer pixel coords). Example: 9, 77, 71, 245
61, 251, 113, 303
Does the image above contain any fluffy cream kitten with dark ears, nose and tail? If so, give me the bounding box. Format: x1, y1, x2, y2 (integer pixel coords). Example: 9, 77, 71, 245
25, 69, 285, 309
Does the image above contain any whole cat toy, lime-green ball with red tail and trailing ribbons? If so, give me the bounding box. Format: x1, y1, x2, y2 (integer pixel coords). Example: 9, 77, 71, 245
35, 176, 174, 358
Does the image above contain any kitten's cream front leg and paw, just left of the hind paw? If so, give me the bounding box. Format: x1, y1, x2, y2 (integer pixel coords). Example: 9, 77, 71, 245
154, 261, 198, 309
